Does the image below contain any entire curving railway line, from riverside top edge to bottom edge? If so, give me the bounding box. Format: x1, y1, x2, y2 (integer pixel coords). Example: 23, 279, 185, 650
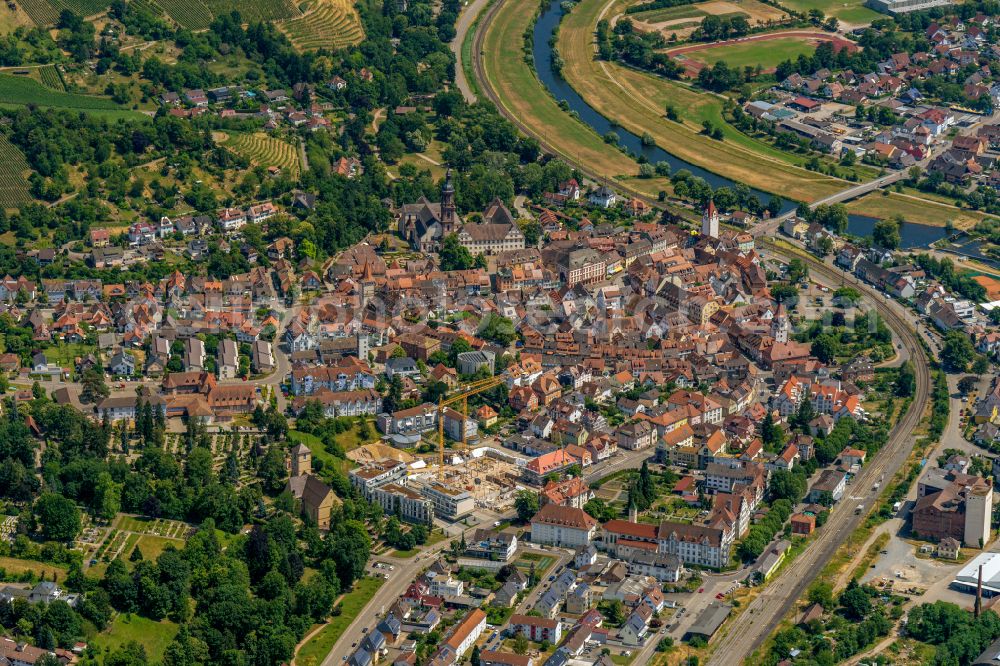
472, 5, 931, 665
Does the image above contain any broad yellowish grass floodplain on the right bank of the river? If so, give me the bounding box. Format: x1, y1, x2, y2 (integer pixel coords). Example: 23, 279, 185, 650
558, 0, 847, 201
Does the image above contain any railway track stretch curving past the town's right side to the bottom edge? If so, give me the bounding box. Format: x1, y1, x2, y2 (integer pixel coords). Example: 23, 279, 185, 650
708, 241, 931, 664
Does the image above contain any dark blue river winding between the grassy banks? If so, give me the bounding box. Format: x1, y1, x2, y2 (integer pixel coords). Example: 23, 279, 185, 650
532, 0, 945, 248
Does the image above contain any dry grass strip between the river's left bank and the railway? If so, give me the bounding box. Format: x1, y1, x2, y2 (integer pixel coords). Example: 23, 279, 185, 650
482, 0, 669, 196
